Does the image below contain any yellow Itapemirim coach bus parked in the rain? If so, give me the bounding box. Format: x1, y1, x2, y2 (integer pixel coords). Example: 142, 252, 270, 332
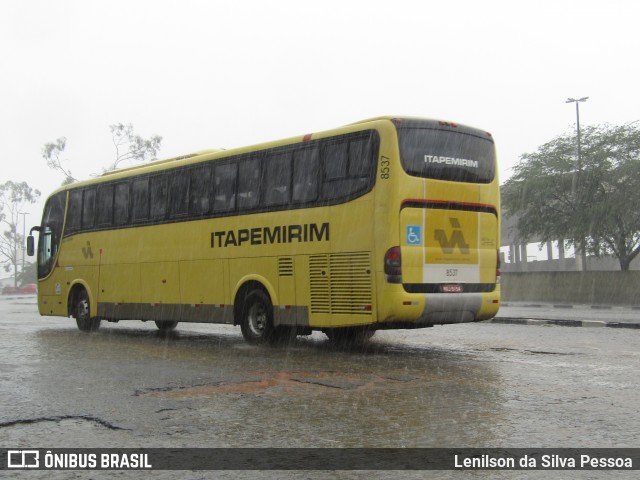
27, 117, 500, 344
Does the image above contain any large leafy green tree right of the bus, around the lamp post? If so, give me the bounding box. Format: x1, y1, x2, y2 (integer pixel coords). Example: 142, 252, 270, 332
502, 123, 640, 270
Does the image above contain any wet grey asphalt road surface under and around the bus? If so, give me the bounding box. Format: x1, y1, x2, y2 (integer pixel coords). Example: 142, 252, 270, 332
0, 297, 640, 479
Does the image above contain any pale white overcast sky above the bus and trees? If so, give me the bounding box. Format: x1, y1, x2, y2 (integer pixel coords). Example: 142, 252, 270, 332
0, 0, 640, 220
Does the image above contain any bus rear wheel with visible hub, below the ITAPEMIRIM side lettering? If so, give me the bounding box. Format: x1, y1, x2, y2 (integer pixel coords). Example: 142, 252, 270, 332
240, 288, 275, 345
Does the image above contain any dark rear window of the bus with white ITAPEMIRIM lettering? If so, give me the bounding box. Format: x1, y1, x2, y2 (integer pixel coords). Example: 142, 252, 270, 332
398, 127, 495, 183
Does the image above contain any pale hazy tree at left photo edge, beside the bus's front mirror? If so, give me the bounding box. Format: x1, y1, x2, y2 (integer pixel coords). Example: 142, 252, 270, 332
0, 181, 40, 287
